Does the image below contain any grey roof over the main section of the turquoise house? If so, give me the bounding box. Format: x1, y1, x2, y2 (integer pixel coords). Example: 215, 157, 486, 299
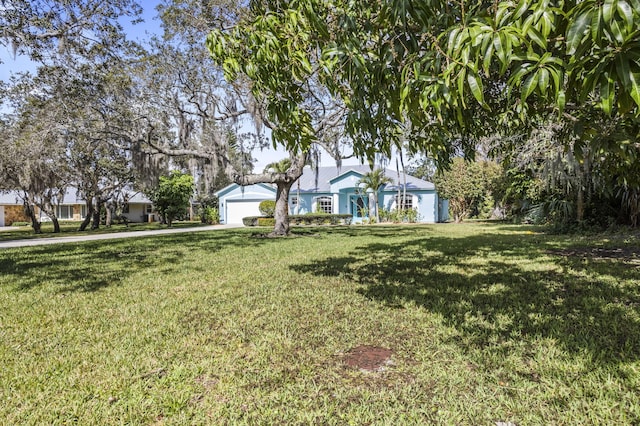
293, 165, 435, 192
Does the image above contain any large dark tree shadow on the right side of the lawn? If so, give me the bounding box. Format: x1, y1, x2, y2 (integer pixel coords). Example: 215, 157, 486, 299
292, 234, 640, 363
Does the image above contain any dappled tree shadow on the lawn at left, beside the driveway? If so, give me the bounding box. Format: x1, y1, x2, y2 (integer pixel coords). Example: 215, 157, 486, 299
0, 231, 268, 293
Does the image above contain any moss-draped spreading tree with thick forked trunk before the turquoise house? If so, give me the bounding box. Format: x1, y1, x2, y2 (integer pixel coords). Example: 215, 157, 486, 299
143, 0, 352, 236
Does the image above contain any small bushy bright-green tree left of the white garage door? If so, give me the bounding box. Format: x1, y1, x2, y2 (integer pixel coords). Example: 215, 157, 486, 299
149, 170, 194, 227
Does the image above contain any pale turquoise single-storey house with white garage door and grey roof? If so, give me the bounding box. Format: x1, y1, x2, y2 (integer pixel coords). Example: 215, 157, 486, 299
215, 166, 449, 224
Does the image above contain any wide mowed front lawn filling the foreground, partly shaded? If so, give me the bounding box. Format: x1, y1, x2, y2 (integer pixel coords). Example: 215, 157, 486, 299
0, 224, 640, 425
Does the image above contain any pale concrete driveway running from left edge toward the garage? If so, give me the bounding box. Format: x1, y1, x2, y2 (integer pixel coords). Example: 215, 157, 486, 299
0, 225, 243, 250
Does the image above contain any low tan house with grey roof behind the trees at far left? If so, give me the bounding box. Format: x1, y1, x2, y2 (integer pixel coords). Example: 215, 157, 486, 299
0, 187, 155, 226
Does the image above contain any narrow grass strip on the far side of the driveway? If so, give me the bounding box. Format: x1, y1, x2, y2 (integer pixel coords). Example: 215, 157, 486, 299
0, 221, 204, 242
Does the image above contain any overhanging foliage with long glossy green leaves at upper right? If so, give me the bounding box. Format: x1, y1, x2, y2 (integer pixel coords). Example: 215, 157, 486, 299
208, 0, 640, 165
